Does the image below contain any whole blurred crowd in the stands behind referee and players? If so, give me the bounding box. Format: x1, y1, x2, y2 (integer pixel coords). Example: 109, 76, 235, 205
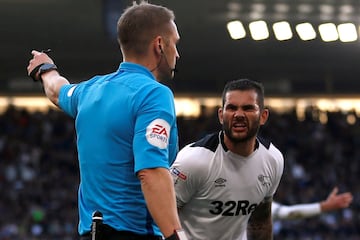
0, 106, 360, 240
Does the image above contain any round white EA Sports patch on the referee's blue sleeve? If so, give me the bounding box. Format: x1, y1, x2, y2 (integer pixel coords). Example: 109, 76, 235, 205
146, 118, 170, 149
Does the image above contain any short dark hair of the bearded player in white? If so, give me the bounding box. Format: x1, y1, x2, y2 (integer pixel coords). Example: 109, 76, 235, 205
222, 79, 265, 109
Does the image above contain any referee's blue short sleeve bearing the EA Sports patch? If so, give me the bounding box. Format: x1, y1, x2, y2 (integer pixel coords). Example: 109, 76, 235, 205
133, 85, 178, 172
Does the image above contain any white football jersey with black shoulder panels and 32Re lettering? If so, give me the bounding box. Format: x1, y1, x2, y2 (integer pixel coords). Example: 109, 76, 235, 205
171, 132, 284, 240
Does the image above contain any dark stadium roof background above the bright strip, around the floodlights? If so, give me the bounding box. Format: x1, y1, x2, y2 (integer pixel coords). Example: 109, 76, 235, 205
0, 0, 360, 96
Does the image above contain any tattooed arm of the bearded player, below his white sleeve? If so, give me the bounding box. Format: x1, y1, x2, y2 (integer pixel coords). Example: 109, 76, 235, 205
247, 200, 273, 240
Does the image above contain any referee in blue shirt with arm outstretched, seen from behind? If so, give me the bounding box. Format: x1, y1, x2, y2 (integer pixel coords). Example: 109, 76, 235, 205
27, 2, 186, 240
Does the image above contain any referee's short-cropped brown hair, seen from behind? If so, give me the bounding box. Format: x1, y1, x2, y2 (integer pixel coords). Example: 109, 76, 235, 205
117, 1, 175, 55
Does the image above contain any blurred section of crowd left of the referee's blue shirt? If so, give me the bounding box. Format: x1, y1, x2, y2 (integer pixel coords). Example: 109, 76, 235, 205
0, 106, 79, 240
